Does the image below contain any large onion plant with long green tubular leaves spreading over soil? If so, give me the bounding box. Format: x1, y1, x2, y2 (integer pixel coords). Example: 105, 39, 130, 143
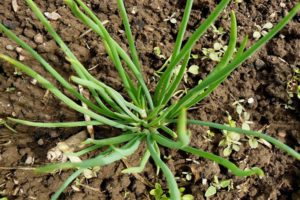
0, 0, 300, 200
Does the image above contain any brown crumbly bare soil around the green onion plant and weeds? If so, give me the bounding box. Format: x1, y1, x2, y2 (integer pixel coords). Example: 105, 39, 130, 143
0, 0, 300, 200
